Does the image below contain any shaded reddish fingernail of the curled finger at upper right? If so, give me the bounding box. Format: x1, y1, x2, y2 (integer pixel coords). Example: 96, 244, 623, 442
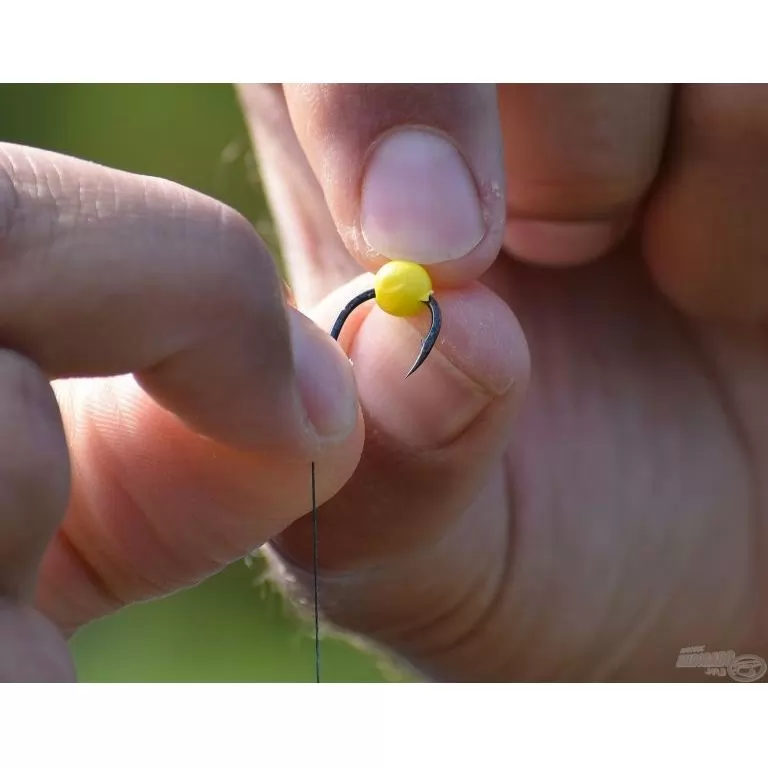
504, 219, 627, 264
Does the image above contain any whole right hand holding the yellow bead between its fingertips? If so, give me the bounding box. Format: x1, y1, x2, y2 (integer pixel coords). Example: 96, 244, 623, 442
241, 86, 768, 680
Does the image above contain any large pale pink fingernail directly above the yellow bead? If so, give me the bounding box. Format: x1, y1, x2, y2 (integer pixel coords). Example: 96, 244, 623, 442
360, 129, 485, 264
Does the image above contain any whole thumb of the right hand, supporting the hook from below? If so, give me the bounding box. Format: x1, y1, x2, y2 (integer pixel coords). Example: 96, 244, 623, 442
274, 276, 530, 579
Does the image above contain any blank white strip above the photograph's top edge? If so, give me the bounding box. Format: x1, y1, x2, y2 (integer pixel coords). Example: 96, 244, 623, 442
0, 0, 768, 82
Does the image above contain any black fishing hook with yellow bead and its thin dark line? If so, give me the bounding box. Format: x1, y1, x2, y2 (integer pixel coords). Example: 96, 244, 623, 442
312, 261, 442, 683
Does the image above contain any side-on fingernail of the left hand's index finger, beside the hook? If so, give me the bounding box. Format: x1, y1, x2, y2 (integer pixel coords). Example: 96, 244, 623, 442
290, 312, 357, 441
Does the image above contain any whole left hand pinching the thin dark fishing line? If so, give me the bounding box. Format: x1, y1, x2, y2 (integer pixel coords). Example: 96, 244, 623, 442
0, 144, 363, 681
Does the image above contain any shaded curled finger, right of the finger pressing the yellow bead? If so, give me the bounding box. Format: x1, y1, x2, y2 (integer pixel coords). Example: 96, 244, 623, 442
498, 84, 672, 266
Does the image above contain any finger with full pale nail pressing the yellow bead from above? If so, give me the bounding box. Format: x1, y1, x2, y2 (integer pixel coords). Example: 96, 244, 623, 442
286, 84, 505, 286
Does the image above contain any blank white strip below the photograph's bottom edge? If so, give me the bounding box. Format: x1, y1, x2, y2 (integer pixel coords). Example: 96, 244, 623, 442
2, 684, 765, 768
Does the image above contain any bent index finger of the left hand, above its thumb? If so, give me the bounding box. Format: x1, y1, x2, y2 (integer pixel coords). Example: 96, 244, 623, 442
0, 144, 356, 456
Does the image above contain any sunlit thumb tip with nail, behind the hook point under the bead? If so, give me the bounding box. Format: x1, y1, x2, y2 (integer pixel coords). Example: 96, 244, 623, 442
351, 284, 530, 450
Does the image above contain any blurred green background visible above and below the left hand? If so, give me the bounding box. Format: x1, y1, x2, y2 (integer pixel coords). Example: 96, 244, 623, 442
0, 85, 396, 682
